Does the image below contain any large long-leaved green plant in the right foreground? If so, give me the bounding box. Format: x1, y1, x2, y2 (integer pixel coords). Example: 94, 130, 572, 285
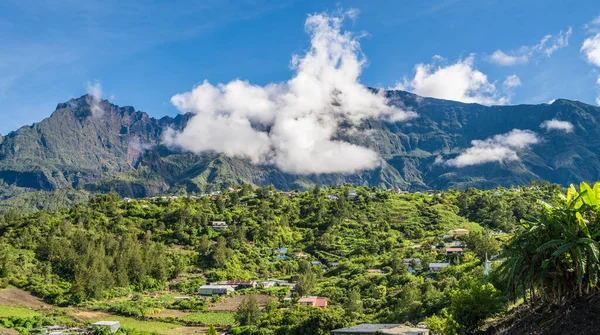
501, 183, 600, 304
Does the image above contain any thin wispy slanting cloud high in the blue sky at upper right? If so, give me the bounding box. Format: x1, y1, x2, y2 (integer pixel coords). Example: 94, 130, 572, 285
488, 27, 573, 66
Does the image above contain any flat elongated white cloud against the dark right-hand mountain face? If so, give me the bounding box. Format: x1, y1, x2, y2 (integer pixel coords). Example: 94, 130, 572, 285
446, 129, 540, 167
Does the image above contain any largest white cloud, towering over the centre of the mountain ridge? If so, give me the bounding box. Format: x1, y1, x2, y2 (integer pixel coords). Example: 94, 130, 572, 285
164, 11, 416, 174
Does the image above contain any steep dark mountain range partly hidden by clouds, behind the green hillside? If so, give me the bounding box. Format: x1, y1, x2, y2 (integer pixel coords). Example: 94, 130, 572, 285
0, 91, 600, 199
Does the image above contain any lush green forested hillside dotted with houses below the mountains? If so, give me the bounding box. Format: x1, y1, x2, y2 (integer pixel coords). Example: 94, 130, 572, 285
0, 184, 560, 334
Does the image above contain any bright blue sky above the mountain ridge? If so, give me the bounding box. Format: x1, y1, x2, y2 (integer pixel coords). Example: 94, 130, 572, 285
0, 0, 600, 134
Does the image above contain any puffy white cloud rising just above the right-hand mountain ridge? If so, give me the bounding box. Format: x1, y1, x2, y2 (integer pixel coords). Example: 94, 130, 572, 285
394, 54, 509, 105
